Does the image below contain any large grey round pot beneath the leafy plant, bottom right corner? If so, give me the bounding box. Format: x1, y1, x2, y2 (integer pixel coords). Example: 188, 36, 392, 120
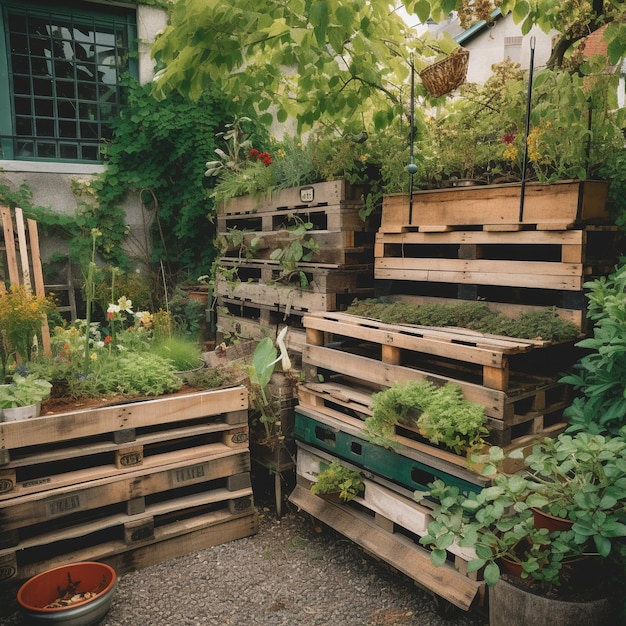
489, 579, 619, 626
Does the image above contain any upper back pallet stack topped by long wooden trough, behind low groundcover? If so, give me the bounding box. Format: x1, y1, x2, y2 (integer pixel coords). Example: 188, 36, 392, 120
375, 181, 621, 329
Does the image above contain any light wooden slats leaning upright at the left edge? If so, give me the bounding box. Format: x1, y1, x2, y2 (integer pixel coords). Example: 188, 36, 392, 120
0, 206, 50, 354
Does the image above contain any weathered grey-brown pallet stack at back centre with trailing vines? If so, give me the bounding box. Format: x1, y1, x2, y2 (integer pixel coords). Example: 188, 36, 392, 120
217, 180, 375, 351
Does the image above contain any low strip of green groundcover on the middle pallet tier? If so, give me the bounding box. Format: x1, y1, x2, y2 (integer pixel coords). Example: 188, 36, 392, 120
347, 299, 580, 341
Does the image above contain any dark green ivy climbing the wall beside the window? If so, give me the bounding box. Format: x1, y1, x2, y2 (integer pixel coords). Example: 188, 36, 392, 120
101, 81, 227, 275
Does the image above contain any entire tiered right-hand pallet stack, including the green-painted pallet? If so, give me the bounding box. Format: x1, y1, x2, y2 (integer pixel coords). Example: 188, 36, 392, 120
291, 182, 619, 610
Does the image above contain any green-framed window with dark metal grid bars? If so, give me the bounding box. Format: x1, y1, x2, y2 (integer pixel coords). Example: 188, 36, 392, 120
0, 0, 137, 163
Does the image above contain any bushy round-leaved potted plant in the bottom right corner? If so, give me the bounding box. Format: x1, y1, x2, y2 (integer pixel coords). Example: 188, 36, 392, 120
417, 433, 626, 626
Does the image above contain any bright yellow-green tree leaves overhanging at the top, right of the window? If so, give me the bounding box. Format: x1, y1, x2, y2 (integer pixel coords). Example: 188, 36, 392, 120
153, 0, 424, 132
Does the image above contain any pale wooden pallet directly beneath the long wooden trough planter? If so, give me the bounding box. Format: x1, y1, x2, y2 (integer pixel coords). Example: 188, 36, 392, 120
375, 227, 619, 292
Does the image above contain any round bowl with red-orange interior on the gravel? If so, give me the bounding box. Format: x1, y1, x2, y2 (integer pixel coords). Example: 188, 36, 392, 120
17, 561, 117, 626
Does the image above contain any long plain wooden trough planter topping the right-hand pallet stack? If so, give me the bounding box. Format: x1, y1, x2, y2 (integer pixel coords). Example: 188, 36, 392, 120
380, 181, 609, 233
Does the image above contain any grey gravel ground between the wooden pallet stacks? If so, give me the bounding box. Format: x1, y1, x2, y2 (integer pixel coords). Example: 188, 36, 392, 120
0, 472, 488, 626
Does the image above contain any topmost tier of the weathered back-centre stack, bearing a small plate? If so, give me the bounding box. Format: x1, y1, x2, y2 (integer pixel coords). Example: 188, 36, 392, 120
217, 180, 368, 216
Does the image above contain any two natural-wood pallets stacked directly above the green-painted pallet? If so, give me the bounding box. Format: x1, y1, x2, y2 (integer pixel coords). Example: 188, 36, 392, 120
300, 312, 574, 446
